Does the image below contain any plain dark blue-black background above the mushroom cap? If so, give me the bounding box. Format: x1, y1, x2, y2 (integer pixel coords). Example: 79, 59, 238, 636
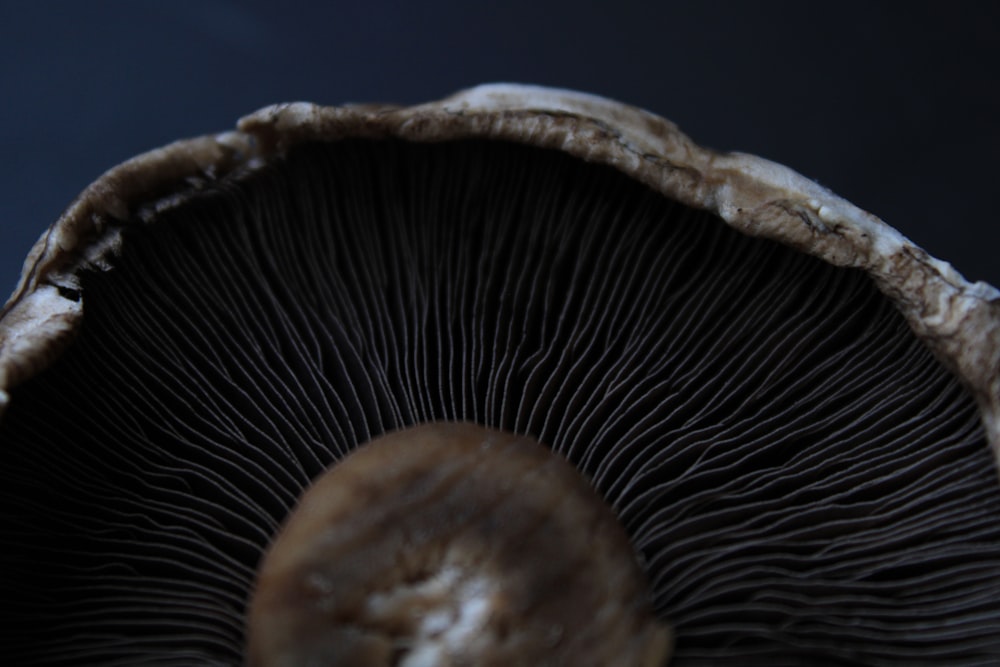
0, 0, 1000, 298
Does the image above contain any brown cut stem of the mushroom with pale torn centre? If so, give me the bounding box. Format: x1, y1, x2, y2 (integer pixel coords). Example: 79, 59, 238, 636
248, 423, 670, 667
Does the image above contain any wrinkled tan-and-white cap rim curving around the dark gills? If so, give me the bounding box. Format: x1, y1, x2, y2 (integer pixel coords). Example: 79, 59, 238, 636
0, 84, 1000, 470
